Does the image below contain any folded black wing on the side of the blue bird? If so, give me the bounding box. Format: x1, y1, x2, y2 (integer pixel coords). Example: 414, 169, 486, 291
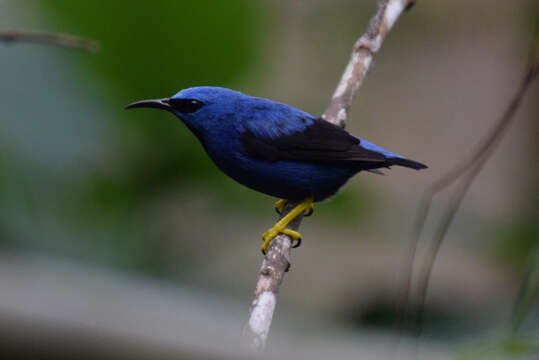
240, 119, 388, 167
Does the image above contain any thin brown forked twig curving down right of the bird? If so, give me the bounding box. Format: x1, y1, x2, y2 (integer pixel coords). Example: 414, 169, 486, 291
399, 23, 539, 335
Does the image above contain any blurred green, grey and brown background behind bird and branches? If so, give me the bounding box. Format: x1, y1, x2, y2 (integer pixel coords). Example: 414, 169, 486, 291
0, 0, 539, 359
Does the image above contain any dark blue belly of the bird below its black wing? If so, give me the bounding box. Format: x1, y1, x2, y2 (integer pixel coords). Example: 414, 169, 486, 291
214, 153, 357, 201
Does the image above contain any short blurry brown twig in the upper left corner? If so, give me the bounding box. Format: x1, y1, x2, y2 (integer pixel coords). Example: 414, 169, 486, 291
0, 30, 99, 52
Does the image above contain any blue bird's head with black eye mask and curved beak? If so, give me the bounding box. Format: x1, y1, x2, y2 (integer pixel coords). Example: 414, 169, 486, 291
126, 86, 247, 137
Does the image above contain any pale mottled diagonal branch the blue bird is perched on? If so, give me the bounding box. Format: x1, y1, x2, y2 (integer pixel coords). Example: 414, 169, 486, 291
243, 0, 413, 353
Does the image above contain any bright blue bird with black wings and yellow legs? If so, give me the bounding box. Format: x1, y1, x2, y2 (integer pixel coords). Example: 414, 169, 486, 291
126, 86, 426, 253
